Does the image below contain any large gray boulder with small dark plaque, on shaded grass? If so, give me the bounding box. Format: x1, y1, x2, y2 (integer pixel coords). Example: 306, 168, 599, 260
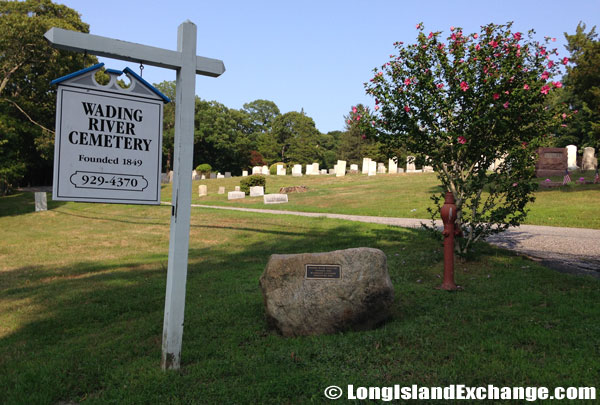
260, 248, 394, 336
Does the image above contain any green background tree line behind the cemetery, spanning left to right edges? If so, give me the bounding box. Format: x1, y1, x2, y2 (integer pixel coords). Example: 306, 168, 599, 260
0, 0, 600, 195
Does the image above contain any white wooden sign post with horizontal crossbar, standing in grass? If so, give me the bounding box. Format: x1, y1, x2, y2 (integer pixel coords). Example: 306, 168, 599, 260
44, 21, 225, 370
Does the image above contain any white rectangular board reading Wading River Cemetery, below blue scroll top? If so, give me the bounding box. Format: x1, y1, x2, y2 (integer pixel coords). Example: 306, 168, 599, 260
52, 85, 163, 204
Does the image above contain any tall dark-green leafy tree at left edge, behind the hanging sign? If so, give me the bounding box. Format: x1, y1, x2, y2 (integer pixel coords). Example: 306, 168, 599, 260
0, 0, 91, 192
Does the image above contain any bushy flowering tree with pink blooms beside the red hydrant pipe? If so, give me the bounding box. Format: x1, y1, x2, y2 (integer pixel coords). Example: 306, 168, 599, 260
360, 23, 568, 253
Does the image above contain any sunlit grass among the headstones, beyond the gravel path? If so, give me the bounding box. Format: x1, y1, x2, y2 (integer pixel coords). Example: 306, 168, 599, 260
183, 171, 600, 229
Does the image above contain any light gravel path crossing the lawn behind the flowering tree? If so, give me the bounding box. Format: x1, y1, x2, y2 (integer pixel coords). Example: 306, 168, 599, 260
192, 204, 600, 279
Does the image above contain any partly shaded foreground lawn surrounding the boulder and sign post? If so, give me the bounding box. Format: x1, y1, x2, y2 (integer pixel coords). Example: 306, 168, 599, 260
0, 191, 600, 404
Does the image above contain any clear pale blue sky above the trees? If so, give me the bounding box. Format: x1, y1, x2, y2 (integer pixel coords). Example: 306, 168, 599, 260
55, 0, 600, 132
